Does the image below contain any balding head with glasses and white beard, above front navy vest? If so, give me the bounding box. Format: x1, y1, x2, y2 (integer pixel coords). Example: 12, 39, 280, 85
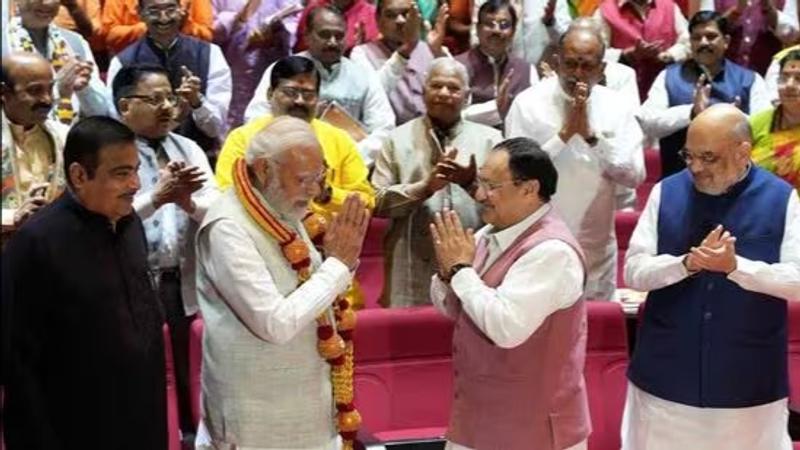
685, 103, 753, 195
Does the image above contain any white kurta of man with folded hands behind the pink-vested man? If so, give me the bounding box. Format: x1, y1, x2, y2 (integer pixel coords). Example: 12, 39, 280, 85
506, 77, 645, 300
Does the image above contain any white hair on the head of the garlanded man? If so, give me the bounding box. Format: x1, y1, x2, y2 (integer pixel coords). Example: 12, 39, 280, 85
244, 116, 319, 166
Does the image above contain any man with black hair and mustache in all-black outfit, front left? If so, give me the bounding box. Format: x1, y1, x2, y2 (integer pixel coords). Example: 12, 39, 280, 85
2, 117, 167, 450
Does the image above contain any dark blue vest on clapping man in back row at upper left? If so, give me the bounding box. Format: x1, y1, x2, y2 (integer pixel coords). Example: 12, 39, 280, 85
117, 34, 214, 153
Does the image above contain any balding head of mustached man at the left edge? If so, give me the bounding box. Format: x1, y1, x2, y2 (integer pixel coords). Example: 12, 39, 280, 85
0, 52, 53, 126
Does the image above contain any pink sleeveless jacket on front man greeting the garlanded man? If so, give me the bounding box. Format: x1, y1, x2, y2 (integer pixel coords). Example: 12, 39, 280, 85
447, 210, 591, 450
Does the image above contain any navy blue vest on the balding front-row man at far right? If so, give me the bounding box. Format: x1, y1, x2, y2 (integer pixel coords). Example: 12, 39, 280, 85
628, 166, 792, 408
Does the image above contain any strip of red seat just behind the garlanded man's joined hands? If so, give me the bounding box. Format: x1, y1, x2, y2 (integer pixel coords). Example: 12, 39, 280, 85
356, 217, 389, 309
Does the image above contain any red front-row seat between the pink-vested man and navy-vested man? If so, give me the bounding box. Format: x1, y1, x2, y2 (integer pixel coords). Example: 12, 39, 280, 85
583, 301, 629, 450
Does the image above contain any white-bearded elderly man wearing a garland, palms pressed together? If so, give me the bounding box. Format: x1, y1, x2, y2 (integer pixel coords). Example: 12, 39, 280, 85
197, 116, 369, 450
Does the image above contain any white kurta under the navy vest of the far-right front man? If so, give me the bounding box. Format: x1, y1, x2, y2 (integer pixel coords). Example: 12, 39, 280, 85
622, 183, 800, 450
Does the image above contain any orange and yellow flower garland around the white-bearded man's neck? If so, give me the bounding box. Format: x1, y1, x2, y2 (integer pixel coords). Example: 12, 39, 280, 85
233, 158, 361, 450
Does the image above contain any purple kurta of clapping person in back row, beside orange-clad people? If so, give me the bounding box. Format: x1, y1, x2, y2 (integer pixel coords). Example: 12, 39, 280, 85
211, 0, 300, 130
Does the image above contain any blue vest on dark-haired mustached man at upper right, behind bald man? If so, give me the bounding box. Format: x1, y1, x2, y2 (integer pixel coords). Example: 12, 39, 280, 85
659, 60, 755, 178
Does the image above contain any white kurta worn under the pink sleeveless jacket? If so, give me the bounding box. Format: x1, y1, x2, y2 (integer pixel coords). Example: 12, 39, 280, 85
431, 204, 587, 450
